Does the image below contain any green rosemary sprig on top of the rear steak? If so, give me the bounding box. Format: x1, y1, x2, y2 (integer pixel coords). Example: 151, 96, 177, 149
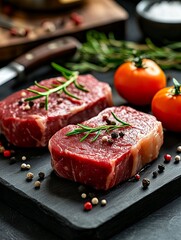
25, 63, 88, 110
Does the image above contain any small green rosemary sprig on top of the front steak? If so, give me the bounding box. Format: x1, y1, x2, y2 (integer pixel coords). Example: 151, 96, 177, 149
66, 112, 131, 142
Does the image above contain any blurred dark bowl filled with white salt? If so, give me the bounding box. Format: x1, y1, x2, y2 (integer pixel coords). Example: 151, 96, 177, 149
136, 0, 181, 44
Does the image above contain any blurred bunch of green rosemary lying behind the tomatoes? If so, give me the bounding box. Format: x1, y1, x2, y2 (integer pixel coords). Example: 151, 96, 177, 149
67, 31, 181, 72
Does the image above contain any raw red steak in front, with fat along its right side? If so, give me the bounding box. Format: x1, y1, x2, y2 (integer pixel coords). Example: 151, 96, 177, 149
49, 106, 163, 190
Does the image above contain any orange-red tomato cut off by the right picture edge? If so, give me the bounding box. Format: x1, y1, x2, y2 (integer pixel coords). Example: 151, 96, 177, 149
151, 84, 181, 132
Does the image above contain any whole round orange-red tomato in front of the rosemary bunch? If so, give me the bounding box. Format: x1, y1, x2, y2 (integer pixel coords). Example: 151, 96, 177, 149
114, 59, 166, 106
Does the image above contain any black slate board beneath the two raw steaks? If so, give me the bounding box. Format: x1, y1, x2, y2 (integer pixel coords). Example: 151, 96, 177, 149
0, 68, 181, 240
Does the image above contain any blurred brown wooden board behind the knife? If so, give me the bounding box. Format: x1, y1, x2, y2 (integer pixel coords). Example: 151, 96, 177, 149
0, 0, 128, 61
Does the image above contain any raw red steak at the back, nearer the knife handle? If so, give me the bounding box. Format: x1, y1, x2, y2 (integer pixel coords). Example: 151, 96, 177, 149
0, 75, 112, 147
